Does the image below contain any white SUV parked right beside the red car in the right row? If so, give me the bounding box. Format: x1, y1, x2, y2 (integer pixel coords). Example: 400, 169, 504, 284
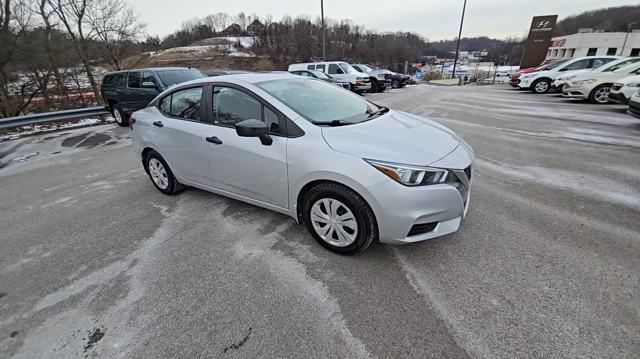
518, 56, 621, 94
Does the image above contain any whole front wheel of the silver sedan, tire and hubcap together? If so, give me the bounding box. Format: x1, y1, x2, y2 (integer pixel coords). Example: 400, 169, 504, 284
303, 183, 378, 255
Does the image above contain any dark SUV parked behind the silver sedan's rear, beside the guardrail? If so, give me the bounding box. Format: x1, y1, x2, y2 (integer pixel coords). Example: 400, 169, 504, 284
100, 67, 205, 126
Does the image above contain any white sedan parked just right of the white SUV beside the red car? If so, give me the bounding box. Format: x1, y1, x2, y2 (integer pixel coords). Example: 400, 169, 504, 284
562, 58, 640, 104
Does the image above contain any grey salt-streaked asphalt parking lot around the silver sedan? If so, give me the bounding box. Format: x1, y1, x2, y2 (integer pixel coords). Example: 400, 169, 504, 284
0, 85, 640, 358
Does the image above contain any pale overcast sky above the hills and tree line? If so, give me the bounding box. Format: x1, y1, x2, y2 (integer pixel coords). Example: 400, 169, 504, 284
129, 0, 638, 40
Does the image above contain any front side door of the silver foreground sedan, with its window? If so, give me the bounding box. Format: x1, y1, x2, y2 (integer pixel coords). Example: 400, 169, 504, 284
209, 85, 289, 208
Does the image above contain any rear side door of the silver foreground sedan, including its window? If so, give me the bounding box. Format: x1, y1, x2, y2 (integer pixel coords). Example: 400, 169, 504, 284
151, 86, 213, 187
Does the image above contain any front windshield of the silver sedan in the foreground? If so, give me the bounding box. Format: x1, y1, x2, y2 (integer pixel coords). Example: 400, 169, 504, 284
256, 79, 381, 124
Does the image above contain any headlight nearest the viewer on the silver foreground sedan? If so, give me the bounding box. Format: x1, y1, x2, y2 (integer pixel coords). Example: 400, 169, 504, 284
365, 160, 449, 186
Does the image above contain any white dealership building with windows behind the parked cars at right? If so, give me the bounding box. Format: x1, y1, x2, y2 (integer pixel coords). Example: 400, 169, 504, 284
547, 29, 640, 58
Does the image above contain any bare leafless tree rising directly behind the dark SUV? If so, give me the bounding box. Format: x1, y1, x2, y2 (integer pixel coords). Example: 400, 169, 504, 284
86, 0, 145, 70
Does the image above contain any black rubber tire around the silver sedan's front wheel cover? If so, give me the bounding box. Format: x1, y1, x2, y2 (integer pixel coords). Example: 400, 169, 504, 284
302, 183, 378, 255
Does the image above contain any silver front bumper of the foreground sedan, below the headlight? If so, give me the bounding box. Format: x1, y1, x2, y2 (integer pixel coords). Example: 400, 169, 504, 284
369, 146, 475, 244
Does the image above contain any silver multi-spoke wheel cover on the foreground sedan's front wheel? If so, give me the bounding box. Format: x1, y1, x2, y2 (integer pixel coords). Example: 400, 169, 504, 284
310, 198, 358, 247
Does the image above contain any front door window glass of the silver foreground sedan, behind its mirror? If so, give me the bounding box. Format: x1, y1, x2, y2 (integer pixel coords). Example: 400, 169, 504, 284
213, 86, 281, 134
